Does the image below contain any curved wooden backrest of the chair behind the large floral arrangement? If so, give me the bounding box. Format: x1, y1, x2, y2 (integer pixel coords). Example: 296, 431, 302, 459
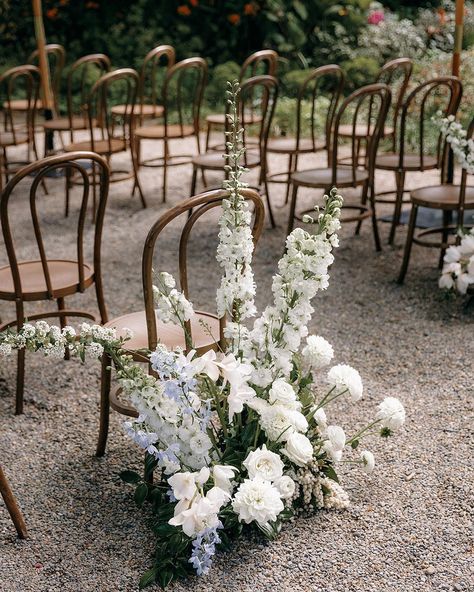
142, 189, 265, 350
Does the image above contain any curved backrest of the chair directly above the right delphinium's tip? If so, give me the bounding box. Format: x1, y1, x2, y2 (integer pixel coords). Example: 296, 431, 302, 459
331, 83, 392, 186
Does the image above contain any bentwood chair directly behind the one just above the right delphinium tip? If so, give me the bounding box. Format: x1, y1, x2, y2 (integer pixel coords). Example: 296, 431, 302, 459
267, 64, 344, 204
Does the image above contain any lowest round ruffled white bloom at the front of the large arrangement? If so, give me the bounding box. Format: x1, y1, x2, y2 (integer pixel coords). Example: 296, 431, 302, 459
232, 477, 284, 526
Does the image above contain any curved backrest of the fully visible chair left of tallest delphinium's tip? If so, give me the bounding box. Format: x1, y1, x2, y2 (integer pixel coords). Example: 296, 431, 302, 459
163, 57, 207, 136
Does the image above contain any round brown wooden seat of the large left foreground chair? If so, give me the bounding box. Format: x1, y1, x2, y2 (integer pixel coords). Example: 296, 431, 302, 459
0, 259, 94, 300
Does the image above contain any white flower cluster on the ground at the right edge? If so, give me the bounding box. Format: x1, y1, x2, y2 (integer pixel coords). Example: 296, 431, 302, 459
439, 228, 474, 294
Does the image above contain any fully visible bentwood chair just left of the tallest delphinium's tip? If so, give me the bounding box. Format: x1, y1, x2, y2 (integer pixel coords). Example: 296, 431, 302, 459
132, 58, 207, 202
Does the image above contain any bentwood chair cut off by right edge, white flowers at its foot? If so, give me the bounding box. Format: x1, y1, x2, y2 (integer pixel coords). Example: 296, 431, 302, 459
398, 119, 474, 284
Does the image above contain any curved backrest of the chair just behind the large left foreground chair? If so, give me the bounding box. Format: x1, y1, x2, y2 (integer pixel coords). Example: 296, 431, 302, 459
87, 68, 139, 153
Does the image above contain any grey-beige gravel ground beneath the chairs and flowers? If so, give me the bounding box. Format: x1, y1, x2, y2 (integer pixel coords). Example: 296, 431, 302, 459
0, 135, 474, 592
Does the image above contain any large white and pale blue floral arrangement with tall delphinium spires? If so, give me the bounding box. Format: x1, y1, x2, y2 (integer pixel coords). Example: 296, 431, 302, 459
0, 83, 405, 588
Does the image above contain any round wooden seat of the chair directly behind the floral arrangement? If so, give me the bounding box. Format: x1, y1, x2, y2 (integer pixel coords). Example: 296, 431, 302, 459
105, 310, 220, 353
